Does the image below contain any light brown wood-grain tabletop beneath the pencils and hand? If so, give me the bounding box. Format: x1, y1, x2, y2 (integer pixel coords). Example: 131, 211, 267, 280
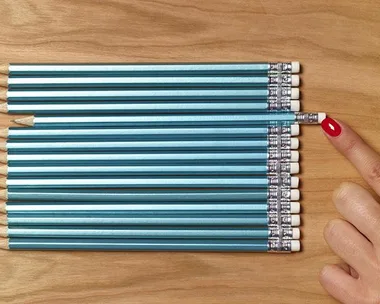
0, 0, 380, 304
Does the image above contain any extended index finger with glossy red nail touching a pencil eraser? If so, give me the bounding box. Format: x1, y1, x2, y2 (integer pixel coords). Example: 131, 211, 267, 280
321, 118, 380, 195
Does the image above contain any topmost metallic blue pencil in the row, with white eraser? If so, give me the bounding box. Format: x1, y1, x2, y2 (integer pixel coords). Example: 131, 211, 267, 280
0, 61, 300, 77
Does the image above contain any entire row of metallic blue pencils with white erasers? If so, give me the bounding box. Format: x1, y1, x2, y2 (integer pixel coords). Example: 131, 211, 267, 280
0, 62, 325, 252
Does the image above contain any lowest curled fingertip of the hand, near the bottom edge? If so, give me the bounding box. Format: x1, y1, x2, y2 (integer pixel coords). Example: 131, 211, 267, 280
319, 265, 360, 303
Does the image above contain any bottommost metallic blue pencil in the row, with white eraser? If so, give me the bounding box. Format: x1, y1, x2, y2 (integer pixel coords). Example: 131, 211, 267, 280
0, 238, 301, 252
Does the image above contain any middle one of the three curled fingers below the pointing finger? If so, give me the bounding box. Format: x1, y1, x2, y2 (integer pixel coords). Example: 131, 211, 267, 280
324, 219, 374, 275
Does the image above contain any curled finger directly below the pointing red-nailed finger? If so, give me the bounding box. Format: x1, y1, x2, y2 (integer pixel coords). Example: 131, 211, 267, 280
333, 183, 380, 244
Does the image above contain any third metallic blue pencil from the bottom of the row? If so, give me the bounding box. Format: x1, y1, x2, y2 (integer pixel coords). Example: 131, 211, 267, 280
0, 213, 300, 227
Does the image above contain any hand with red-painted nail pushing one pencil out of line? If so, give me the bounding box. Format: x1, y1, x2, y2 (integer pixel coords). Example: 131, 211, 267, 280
320, 118, 380, 304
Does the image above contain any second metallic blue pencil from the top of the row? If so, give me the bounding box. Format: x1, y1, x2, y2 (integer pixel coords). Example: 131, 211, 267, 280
3, 74, 300, 90
